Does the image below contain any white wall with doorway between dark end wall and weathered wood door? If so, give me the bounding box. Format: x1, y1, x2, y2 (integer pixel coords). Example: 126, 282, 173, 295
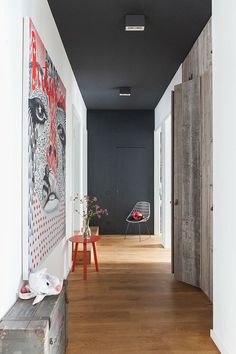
154, 65, 182, 248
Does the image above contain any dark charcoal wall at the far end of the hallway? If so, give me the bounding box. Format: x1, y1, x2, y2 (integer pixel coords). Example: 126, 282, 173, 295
87, 110, 154, 234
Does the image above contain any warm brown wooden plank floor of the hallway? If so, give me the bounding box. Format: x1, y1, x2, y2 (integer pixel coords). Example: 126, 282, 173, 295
67, 236, 219, 354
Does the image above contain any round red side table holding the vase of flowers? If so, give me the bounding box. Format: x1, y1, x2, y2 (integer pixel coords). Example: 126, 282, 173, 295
69, 235, 101, 280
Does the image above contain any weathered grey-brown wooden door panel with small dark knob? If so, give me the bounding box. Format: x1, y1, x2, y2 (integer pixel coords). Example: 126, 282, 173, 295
172, 78, 201, 287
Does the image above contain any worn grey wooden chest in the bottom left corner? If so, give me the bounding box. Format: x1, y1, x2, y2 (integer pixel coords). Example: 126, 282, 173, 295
0, 285, 67, 354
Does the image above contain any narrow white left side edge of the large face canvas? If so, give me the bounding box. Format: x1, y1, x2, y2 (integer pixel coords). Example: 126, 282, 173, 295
21, 17, 30, 280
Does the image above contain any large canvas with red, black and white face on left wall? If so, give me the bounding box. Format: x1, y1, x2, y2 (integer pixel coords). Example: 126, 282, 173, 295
28, 20, 66, 271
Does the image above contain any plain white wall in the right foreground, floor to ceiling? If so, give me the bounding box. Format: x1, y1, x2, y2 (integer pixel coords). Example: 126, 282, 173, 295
212, 0, 236, 354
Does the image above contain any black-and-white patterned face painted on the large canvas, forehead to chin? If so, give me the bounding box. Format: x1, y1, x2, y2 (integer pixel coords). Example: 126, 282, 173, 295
29, 71, 65, 213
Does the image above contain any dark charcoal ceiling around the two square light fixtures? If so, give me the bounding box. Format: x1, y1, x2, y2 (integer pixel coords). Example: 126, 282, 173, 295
48, 0, 211, 109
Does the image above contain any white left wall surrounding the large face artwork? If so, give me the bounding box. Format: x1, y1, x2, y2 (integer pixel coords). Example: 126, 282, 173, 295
0, 0, 87, 318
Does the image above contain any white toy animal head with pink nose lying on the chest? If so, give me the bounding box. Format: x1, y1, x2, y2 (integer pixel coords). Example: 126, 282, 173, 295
19, 268, 62, 305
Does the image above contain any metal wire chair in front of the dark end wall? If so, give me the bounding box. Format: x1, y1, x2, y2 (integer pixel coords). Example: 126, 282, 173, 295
125, 202, 151, 241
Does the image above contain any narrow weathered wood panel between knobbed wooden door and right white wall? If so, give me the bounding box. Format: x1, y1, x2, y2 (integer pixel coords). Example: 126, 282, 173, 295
200, 68, 213, 300
